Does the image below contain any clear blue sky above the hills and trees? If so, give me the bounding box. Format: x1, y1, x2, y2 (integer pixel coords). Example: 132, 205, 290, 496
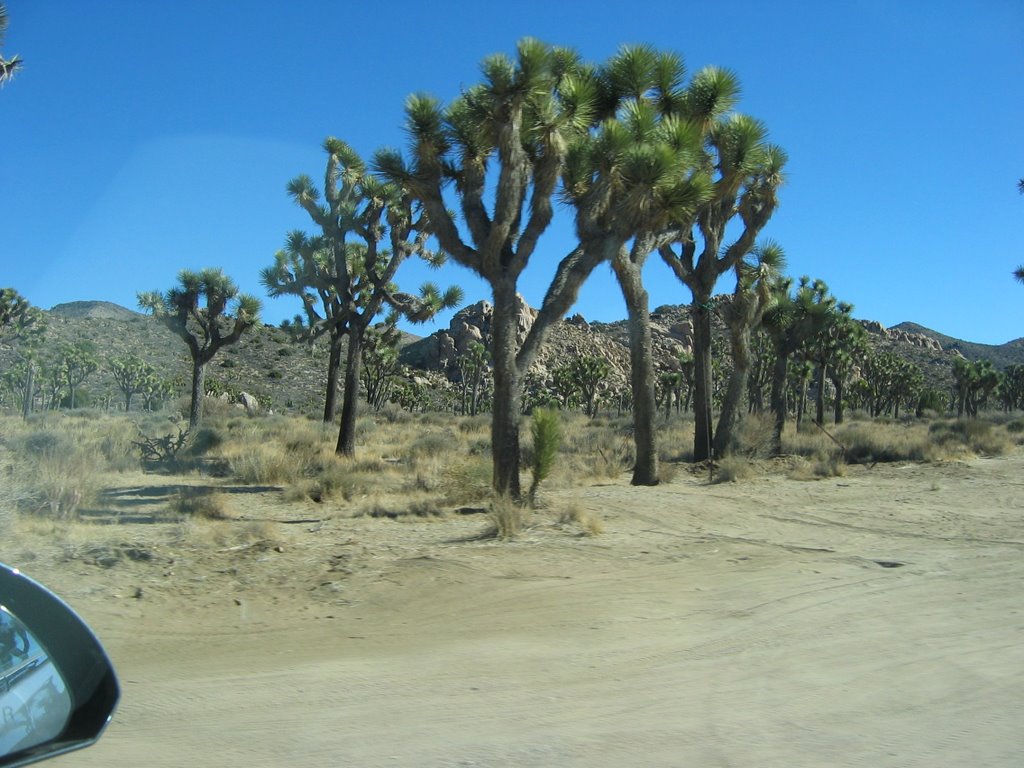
0, 0, 1024, 344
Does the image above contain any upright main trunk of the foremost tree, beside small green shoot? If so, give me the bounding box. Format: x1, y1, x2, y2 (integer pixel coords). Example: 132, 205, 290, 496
490, 275, 521, 501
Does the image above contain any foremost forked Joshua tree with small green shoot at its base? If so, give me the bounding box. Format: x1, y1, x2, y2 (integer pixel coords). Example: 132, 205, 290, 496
376, 39, 596, 499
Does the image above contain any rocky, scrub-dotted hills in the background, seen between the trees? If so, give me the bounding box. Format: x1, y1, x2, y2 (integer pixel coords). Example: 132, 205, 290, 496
0, 297, 999, 417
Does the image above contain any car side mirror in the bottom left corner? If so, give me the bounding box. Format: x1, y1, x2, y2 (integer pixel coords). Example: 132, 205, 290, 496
0, 563, 120, 766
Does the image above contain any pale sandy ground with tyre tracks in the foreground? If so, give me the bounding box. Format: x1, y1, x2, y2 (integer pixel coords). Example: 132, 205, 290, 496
8, 453, 1024, 768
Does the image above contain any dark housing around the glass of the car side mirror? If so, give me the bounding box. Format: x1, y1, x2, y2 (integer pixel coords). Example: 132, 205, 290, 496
0, 563, 120, 767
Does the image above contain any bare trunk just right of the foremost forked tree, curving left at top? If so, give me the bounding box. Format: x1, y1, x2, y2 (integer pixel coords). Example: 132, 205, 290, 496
612, 256, 671, 485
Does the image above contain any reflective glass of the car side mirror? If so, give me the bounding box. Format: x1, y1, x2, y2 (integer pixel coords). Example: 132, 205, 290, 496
0, 605, 72, 757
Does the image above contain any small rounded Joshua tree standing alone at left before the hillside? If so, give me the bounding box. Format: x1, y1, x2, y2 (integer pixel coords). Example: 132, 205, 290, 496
138, 268, 260, 429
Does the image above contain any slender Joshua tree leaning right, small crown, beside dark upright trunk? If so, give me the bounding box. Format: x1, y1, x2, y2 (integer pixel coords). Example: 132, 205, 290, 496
715, 241, 785, 456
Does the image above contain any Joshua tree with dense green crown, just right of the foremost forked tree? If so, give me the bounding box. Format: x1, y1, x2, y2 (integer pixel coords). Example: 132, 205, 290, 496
564, 46, 711, 485
